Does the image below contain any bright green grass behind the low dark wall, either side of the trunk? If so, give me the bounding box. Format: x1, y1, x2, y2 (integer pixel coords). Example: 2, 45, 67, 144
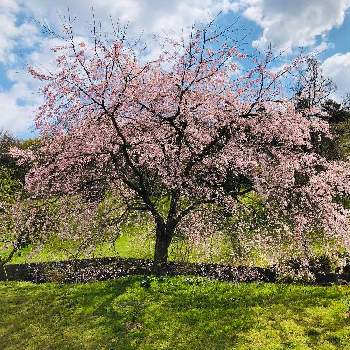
10, 225, 231, 264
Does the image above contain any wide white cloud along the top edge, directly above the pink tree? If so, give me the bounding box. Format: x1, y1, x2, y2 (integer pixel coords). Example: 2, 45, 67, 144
22, 0, 238, 34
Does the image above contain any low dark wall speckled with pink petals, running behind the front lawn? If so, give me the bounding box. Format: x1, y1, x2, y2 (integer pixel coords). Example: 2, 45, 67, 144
0, 258, 350, 285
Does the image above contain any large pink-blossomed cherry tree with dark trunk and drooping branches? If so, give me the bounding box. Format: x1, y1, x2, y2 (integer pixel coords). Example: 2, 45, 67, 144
12, 21, 350, 264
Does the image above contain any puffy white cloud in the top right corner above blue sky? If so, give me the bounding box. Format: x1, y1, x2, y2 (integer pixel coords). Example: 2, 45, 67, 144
240, 0, 350, 52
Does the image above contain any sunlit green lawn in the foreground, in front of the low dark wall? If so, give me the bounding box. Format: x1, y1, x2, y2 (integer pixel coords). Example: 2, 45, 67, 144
0, 277, 350, 350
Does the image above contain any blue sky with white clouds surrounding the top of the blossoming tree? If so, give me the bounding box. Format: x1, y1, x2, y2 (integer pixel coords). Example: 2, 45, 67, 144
0, 0, 350, 137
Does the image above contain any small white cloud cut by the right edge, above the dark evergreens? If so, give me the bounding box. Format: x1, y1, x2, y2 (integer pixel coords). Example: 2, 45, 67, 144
322, 52, 350, 98
